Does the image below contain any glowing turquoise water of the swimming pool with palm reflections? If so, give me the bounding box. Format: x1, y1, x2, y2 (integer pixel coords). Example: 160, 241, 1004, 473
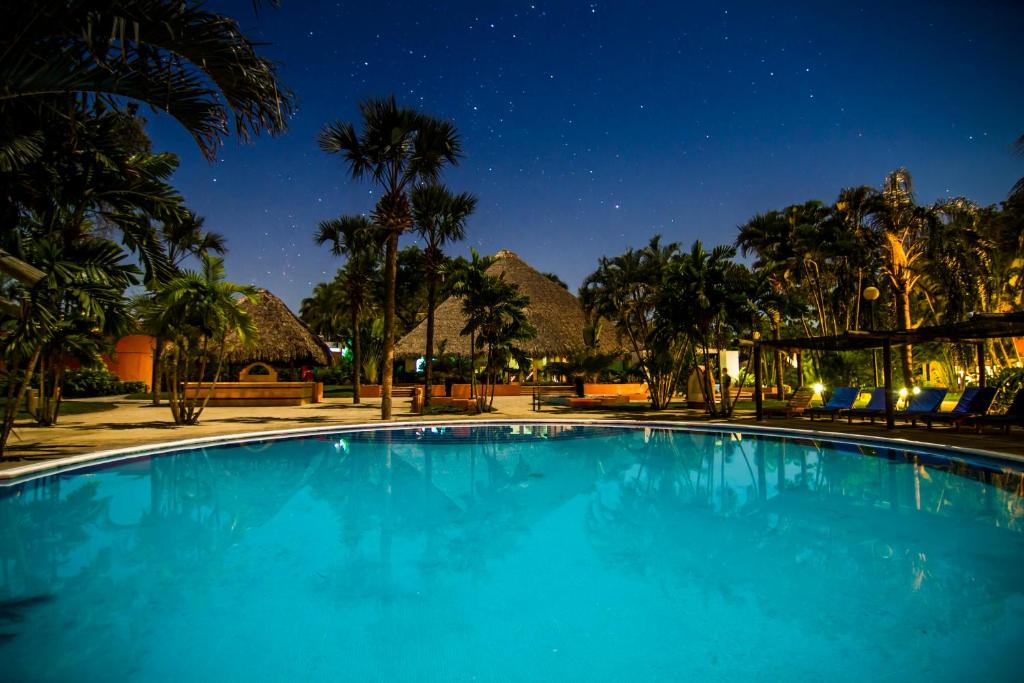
0, 425, 1024, 681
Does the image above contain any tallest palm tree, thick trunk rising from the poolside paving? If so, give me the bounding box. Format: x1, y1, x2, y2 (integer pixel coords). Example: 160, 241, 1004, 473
317, 96, 462, 420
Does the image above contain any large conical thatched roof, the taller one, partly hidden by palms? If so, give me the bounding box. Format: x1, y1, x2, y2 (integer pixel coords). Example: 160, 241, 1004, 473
395, 250, 618, 358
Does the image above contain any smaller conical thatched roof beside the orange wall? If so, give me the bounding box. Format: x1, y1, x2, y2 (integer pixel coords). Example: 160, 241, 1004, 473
224, 289, 331, 366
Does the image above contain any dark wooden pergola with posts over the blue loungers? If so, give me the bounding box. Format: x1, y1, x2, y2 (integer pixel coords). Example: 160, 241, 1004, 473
754, 311, 1024, 429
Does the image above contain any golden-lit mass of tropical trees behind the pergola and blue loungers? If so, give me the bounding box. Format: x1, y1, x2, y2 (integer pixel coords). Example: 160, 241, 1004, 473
736, 169, 1024, 386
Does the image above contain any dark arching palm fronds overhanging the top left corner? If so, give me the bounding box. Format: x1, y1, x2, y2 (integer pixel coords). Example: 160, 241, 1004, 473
0, 0, 294, 161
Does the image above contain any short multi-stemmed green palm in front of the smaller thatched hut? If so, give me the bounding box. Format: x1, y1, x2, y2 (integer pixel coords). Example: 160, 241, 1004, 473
144, 254, 256, 425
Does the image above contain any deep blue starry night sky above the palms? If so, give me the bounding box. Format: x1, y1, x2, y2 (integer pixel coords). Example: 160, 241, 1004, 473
147, 0, 1024, 309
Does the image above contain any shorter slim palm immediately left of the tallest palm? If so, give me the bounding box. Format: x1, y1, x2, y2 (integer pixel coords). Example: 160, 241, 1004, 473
315, 216, 380, 403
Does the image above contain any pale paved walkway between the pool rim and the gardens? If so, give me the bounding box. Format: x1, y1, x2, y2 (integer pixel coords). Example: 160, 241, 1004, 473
0, 396, 1024, 470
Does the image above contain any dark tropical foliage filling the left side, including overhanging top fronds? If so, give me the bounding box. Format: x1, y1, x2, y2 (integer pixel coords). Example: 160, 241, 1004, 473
0, 0, 293, 451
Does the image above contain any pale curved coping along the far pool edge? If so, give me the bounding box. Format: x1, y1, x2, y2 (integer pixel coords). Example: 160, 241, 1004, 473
0, 418, 1024, 487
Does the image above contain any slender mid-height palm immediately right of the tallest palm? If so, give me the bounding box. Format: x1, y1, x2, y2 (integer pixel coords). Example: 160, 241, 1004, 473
413, 185, 476, 407
